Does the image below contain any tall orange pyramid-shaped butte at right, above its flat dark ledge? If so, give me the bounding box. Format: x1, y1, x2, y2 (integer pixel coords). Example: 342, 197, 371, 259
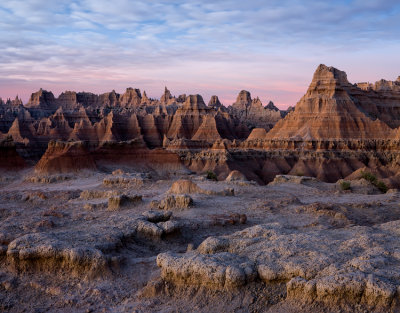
267, 65, 394, 140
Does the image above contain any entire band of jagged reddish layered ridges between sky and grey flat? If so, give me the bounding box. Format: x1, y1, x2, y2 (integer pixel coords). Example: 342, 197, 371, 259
0, 65, 400, 186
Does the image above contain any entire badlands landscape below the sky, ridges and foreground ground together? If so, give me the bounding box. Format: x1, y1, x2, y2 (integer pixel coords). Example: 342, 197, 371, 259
0, 65, 400, 312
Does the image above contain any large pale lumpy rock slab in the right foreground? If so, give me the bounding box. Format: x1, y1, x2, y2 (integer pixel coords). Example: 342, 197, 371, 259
157, 222, 400, 308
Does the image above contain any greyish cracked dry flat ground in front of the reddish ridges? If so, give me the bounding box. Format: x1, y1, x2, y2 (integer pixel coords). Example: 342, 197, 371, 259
0, 173, 400, 312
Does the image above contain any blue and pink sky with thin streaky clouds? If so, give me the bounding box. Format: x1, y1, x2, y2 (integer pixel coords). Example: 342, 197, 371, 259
0, 0, 400, 109
